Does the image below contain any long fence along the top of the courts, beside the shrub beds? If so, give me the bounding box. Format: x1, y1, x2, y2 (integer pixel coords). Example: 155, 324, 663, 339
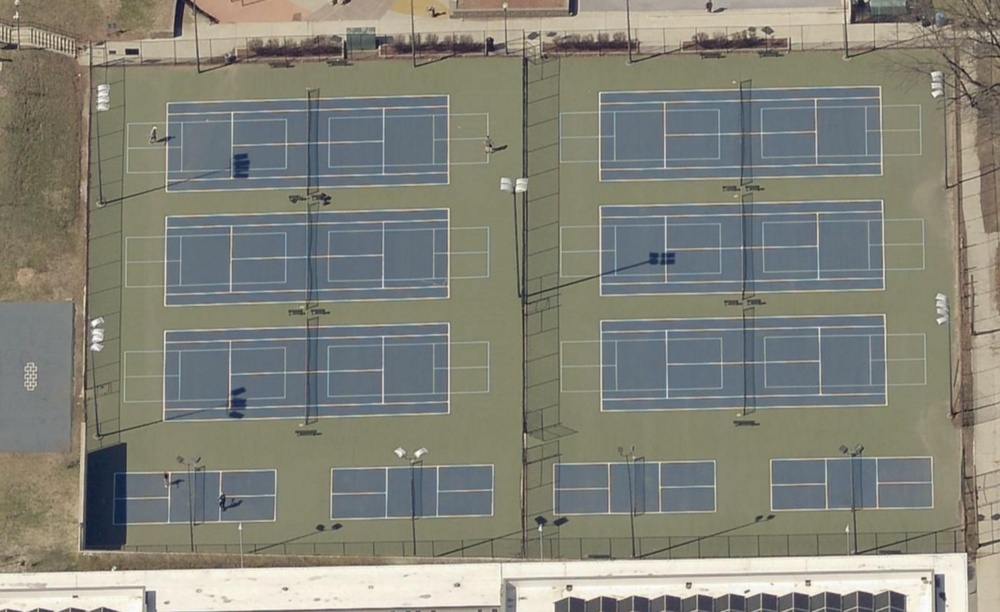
86, 23, 936, 68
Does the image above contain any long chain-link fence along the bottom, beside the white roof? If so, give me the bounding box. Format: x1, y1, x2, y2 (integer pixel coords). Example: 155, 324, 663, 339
122, 526, 965, 560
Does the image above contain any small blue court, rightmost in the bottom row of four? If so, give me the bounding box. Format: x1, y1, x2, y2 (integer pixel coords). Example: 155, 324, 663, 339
771, 457, 934, 510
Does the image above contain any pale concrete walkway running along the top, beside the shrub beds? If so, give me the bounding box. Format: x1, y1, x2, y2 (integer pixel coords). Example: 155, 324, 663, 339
82, 0, 927, 61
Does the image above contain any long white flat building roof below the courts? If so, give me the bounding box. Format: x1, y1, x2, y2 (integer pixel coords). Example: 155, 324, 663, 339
0, 554, 968, 612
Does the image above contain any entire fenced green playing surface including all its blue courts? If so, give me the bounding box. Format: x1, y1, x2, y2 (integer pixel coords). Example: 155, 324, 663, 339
85, 53, 961, 558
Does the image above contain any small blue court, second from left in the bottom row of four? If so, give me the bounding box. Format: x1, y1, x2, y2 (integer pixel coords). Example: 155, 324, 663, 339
330, 464, 493, 519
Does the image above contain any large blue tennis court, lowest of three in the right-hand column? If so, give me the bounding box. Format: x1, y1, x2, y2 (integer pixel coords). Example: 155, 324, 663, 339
601, 315, 887, 410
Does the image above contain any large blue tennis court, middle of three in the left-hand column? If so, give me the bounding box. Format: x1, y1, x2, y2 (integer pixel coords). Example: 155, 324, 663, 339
164, 209, 448, 306
